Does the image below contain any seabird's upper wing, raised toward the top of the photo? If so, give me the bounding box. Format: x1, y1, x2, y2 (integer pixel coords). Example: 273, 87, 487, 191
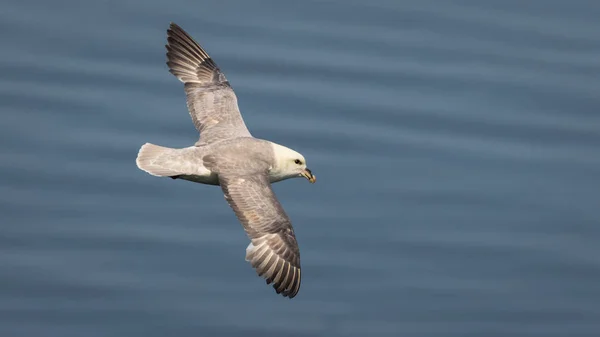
166, 23, 251, 146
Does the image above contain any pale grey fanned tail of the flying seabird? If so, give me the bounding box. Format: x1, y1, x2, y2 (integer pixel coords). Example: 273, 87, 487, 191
135, 143, 181, 177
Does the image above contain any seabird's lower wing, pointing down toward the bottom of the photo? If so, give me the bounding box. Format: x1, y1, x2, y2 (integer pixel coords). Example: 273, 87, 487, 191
219, 172, 301, 298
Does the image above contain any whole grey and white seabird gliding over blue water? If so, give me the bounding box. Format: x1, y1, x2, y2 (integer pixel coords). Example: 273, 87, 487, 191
136, 23, 315, 298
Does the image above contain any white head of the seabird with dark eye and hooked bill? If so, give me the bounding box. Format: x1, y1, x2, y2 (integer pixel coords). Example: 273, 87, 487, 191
270, 143, 317, 183
